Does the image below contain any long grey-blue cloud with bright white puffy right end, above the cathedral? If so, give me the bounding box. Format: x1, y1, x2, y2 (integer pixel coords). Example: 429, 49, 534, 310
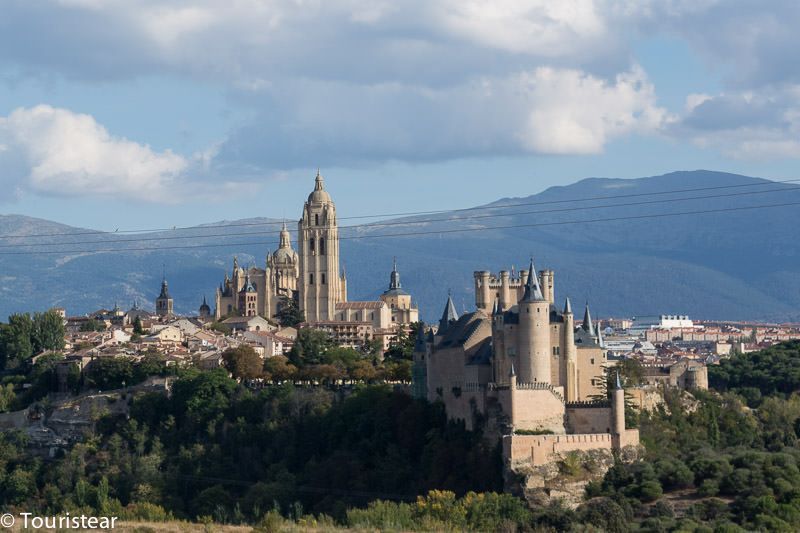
219, 68, 669, 168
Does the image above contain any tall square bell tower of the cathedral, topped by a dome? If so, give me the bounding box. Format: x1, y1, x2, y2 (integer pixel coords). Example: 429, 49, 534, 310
298, 170, 340, 322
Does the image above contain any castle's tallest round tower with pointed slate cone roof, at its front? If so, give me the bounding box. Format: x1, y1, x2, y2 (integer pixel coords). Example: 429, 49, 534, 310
517, 259, 551, 383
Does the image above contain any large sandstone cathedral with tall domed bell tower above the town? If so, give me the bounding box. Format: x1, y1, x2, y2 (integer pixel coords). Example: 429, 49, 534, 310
209, 171, 419, 344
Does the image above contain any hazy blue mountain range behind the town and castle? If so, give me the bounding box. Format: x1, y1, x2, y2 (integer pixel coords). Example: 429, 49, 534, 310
0, 170, 800, 322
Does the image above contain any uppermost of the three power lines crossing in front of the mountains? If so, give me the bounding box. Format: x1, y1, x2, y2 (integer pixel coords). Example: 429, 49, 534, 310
0, 178, 800, 239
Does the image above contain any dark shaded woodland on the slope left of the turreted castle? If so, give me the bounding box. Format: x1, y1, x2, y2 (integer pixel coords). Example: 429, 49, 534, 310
0, 378, 502, 523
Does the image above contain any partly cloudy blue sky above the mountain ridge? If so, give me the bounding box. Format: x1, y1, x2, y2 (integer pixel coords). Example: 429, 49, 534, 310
0, 0, 800, 230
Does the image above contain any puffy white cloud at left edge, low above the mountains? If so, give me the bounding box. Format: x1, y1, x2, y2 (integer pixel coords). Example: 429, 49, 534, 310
0, 105, 189, 202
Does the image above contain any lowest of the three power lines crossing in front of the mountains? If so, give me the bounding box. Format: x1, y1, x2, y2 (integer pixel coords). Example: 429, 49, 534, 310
0, 202, 800, 256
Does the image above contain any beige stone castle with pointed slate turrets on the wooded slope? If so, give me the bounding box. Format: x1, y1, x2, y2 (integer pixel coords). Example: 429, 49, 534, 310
413, 261, 639, 469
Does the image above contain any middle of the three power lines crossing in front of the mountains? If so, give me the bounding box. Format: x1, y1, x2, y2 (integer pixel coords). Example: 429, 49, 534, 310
0, 187, 800, 249
